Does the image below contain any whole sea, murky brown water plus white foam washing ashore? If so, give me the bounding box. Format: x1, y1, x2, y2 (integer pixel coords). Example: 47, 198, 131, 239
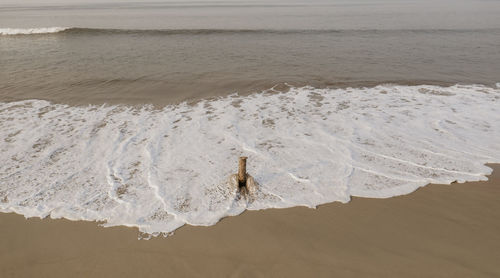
0, 0, 500, 235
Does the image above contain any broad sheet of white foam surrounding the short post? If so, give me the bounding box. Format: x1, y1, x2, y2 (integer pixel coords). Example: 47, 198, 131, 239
0, 85, 500, 235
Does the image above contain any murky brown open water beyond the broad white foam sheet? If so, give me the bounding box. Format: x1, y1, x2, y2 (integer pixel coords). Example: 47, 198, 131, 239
0, 1, 500, 105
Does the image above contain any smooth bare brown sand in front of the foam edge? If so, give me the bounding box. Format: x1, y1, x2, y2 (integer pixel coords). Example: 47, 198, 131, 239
0, 165, 500, 278
